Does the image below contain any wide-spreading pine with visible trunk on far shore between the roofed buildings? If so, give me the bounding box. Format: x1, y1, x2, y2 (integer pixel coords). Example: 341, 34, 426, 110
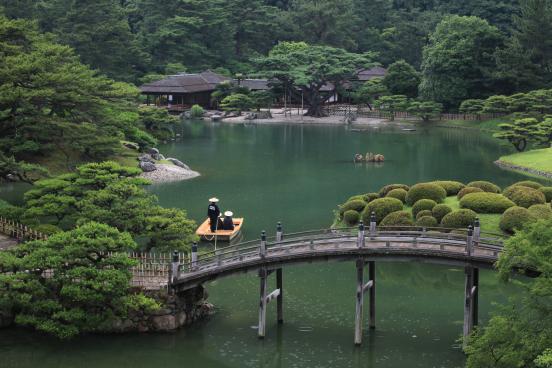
257, 42, 374, 117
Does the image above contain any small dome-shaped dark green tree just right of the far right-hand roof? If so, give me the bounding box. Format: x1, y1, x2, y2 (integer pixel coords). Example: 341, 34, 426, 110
383, 60, 420, 98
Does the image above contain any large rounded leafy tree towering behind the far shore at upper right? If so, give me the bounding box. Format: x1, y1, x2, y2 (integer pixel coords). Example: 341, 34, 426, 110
420, 16, 501, 108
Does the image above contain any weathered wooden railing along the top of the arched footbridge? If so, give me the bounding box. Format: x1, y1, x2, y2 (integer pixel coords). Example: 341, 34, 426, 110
178, 226, 505, 273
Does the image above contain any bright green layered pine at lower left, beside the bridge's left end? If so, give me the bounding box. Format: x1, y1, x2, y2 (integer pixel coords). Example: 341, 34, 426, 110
0, 223, 156, 339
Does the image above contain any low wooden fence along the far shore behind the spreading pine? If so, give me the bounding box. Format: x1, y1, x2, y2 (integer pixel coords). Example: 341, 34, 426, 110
324, 105, 504, 121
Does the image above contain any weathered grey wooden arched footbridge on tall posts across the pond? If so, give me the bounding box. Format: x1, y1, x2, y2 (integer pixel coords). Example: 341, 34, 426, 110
169, 220, 504, 345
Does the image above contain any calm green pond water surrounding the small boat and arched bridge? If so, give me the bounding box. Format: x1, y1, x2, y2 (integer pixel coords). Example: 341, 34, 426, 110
0, 122, 536, 368
